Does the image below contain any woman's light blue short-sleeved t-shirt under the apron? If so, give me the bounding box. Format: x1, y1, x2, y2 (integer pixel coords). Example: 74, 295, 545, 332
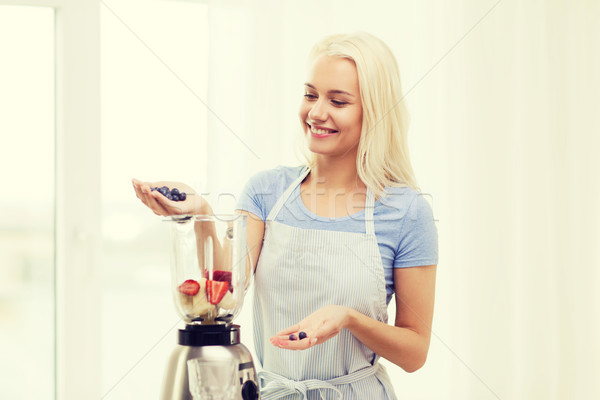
237, 166, 438, 303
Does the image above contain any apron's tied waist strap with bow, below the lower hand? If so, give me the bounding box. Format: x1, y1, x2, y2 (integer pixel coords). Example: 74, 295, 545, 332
258, 363, 379, 400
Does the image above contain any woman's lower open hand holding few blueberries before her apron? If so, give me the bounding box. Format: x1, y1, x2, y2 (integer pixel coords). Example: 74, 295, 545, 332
270, 305, 351, 350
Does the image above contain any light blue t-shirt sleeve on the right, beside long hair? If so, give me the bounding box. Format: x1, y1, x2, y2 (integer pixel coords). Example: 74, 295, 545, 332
394, 193, 438, 268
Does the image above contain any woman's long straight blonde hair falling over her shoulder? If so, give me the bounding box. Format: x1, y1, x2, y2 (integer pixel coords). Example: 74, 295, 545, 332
302, 32, 419, 196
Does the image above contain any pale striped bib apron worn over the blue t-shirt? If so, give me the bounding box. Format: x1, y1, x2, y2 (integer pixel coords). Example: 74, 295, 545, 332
254, 168, 396, 400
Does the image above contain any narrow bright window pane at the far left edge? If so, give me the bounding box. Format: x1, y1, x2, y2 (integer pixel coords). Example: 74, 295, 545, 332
0, 6, 55, 400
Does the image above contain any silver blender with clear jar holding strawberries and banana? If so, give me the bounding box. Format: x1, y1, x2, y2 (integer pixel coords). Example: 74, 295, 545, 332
161, 214, 259, 400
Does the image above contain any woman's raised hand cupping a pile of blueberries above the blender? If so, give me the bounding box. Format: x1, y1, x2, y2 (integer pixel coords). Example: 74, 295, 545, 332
131, 179, 212, 216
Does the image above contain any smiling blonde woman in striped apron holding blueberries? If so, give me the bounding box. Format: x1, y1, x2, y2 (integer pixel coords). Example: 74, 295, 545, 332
134, 33, 437, 399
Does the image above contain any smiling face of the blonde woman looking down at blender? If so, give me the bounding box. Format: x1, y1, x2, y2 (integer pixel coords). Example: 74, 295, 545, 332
300, 55, 362, 158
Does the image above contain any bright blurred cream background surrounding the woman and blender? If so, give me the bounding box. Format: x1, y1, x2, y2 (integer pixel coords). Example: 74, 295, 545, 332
0, 0, 600, 400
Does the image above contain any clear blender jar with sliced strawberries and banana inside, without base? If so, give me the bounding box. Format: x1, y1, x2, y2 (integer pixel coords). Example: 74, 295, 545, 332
165, 214, 252, 324
